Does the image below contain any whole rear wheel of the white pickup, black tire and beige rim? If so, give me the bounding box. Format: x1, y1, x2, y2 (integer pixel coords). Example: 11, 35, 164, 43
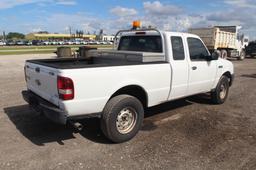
101, 95, 144, 143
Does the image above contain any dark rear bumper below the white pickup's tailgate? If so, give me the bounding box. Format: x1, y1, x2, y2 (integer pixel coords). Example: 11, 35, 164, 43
22, 90, 67, 124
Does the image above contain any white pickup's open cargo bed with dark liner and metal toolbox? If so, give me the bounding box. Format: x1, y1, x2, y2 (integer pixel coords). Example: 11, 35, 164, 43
27, 51, 166, 69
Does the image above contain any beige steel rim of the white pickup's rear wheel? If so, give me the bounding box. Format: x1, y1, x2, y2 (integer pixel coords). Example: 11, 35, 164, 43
116, 107, 137, 134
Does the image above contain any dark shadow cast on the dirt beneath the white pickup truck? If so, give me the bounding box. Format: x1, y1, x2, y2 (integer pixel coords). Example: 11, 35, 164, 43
4, 93, 212, 146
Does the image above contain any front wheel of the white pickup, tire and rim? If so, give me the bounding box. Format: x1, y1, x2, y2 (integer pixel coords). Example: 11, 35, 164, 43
211, 76, 229, 104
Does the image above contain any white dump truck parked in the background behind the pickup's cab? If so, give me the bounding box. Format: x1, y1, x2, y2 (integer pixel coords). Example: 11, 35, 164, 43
188, 26, 249, 60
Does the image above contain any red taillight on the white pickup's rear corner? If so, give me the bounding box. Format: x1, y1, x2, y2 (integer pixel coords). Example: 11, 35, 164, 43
57, 76, 75, 100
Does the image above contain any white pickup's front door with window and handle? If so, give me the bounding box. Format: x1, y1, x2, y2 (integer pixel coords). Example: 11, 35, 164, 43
187, 37, 217, 95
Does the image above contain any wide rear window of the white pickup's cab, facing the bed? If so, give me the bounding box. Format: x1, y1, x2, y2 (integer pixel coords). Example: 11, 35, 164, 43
118, 35, 163, 53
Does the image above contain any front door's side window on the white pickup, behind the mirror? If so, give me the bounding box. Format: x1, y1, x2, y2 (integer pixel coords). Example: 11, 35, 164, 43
187, 38, 209, 61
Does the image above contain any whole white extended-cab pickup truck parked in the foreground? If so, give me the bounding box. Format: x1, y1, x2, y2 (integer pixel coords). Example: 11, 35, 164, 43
22, 29, 234, 143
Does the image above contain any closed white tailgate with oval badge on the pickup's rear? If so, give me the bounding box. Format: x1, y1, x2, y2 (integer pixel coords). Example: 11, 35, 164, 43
25, 62, 59, 106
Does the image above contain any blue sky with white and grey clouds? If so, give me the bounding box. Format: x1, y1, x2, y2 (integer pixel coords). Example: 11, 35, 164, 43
0, 0, 256, 39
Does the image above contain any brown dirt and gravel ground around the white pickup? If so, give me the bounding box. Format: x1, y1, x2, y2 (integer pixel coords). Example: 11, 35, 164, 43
0, 55, 256, 170
